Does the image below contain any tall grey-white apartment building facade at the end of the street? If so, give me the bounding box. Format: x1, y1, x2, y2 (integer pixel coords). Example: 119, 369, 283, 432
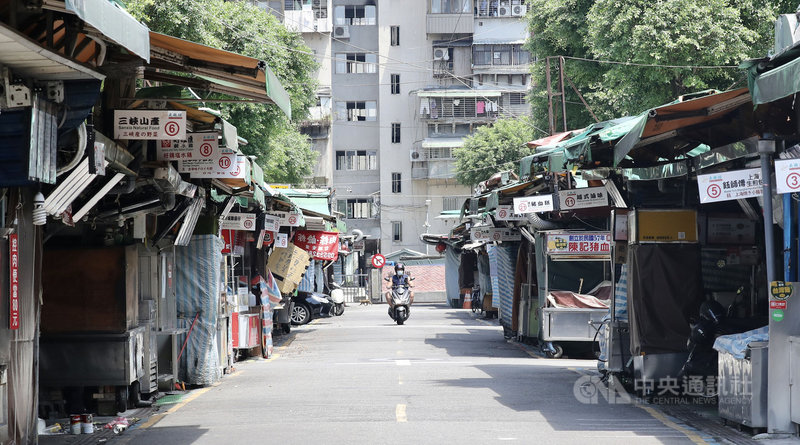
256, 0, 531, 255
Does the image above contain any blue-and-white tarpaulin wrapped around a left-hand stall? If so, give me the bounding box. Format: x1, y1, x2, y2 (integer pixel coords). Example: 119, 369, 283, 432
175, 235, 223, 385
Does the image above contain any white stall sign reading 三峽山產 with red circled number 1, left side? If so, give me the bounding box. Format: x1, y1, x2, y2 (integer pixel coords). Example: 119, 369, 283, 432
114, 110, 186, 140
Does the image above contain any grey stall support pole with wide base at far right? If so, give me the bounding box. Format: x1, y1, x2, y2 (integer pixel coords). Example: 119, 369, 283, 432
758, 139, 794, 434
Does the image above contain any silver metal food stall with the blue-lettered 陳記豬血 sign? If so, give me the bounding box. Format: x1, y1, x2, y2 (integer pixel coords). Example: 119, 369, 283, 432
539, 231, 614, 358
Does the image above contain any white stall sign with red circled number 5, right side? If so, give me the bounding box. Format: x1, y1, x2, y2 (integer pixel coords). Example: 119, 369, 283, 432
697, 168, 762, 204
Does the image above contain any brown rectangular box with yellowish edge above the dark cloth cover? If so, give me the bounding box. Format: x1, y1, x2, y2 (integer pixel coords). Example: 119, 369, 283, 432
628, 209, 698, 244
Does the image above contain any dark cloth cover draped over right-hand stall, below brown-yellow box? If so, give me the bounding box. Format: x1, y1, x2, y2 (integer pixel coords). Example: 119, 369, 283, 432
628, 244, 703, 355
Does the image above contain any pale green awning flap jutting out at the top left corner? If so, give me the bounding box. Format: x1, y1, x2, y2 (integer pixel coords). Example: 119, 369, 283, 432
64, 0, 150, 62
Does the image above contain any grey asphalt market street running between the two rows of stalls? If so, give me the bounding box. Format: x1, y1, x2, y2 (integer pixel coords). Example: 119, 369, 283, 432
116, 304, 700, 445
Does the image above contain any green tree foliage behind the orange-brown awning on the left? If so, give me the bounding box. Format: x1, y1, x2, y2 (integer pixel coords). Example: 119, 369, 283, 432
127, 0, 317, 184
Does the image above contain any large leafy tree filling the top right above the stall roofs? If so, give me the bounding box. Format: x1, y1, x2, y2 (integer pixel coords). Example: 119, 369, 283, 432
528, 0, 796, 130
